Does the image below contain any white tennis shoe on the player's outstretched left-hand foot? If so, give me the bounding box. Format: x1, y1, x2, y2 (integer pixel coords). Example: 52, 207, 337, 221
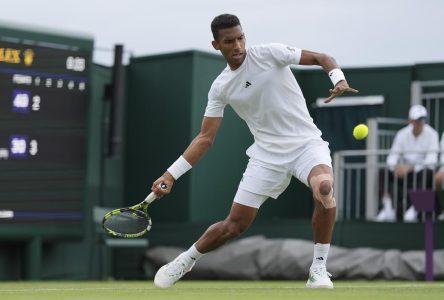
154, 253, 196, 289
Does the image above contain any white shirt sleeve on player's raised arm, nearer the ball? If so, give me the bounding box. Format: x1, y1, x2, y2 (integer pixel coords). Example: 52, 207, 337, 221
255, 43, 302, 66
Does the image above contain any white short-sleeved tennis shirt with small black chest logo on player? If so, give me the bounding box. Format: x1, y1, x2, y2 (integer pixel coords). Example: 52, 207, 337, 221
205, 44, 322, 164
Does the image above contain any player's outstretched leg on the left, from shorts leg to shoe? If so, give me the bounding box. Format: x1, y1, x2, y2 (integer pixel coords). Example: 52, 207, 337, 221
154, 159, 291, 288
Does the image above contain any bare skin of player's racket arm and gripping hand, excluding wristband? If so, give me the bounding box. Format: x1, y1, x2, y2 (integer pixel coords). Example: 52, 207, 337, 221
151, 117, 222, 197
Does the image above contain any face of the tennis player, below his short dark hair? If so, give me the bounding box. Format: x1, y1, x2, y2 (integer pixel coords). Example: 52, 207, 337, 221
212, 25, 246, 70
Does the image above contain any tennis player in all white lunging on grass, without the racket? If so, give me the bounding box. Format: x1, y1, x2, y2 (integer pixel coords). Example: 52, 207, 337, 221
152, 14, 358, 288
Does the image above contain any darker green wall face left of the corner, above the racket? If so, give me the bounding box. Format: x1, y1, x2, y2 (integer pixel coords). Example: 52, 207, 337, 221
125, 52, 193, 221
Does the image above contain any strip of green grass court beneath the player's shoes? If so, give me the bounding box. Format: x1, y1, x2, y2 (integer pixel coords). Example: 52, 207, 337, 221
0, 281, 444, 300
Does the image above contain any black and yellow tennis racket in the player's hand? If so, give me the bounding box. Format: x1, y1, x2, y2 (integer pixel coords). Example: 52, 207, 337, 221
102, 183, 166, 239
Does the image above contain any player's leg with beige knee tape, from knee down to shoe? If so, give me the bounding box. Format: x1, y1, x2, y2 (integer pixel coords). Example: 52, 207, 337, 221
306, 164, 336, 288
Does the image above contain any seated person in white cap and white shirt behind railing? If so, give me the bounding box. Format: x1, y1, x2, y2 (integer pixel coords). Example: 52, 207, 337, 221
376, 105, 439, 222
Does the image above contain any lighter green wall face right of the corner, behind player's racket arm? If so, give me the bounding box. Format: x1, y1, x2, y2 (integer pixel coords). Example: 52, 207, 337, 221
186, 52, 252, 221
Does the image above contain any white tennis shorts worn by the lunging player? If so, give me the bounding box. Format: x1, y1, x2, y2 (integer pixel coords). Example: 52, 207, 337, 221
234, 141, 332, 208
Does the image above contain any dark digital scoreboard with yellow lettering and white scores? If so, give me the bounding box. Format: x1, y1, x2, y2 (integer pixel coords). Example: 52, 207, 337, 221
0, 40, 91, 226
